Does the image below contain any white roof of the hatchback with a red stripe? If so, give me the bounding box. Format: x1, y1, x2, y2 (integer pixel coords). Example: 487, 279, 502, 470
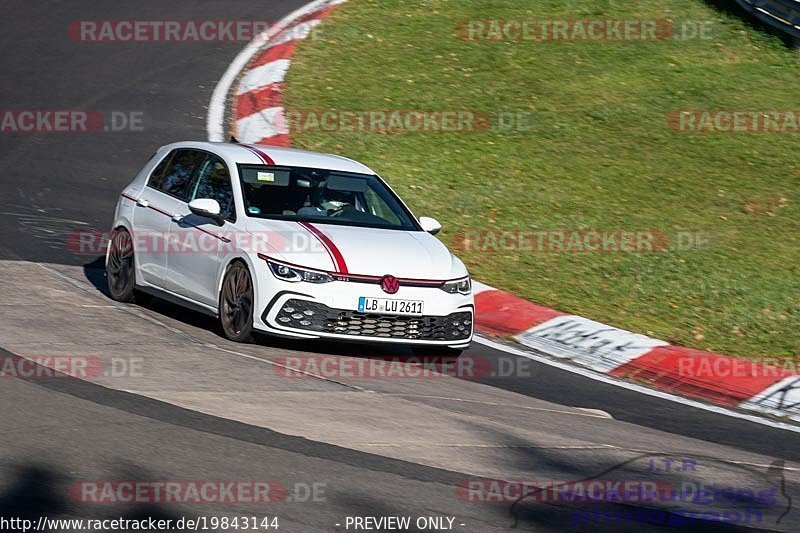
162, 141, 375, 174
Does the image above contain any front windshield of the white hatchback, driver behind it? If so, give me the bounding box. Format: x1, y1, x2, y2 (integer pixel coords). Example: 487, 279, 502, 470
239, 165, 419, 231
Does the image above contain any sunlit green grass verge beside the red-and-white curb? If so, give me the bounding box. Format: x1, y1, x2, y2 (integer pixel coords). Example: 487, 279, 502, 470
286, 0, 800, 356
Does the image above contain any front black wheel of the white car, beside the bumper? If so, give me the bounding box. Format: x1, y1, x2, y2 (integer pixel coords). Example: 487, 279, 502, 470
219, 262, 255, 342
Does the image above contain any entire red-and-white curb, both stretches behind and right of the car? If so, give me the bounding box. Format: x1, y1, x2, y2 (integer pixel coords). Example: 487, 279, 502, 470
207, 0, 800, 424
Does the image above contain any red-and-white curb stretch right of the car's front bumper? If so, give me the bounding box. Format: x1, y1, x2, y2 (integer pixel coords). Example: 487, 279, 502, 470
475, 283, 800, 421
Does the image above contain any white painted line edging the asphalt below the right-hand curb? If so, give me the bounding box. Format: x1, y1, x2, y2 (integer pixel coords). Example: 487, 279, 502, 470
474, 335, 800, 433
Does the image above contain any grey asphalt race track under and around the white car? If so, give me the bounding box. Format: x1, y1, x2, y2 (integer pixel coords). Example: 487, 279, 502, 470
0, 0, 800, 532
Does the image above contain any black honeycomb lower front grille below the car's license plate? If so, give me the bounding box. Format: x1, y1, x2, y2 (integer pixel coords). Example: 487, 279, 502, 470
275, 300, 472, 341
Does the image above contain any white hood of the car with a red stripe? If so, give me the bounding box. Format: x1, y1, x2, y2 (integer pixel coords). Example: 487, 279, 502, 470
248, 219, 467, 280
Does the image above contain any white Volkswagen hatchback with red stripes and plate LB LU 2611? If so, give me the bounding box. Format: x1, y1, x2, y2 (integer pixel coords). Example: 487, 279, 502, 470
106, 142, 474, 353
